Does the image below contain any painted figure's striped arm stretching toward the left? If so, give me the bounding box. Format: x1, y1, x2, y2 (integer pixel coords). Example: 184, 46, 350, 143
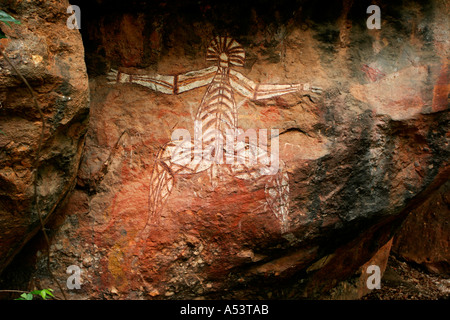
107, 66, 217, 94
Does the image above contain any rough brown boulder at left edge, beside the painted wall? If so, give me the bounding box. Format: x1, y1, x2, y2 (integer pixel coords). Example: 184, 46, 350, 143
0, 1, 89, 272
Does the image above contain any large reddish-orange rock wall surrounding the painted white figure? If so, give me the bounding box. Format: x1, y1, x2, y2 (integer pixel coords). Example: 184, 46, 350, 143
0, 1, 449, 299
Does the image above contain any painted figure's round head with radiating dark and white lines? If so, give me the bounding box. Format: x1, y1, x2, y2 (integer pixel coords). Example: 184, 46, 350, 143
206, 36, 245, 68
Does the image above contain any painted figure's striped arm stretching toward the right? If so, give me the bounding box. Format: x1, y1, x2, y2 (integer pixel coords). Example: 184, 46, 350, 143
230, 70, 322, 100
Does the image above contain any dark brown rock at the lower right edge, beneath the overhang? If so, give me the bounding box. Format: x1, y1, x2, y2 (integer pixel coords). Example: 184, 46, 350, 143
393, 182, 450, 275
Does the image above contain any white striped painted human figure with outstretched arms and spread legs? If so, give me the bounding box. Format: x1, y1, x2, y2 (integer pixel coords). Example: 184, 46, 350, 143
108, 36, 321, 232
